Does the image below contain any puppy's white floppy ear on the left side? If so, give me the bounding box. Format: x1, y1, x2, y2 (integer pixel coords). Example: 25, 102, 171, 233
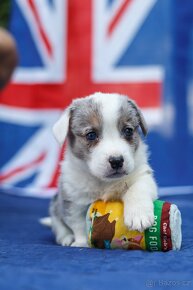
52, 107, 71, 146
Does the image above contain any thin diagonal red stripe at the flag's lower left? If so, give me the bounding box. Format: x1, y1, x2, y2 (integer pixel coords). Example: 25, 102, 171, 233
0, 152, 46, 182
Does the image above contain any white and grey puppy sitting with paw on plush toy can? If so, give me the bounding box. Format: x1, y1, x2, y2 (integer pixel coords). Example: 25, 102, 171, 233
50, 93, 157, 246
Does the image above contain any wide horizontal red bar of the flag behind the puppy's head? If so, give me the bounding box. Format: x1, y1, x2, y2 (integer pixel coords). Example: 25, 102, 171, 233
0, 82, 162, 109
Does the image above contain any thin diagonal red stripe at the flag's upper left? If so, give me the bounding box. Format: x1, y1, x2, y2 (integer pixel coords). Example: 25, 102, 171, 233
28, 0, 53, 56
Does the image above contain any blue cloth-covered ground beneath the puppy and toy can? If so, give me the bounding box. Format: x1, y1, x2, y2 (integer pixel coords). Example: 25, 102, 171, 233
0, 193, 193, 290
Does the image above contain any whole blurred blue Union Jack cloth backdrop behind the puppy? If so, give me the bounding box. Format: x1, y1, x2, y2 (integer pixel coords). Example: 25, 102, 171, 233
0, 0, 193, 196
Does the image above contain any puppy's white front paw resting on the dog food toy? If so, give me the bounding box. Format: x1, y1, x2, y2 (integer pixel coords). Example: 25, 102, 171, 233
124, 204, 154, 232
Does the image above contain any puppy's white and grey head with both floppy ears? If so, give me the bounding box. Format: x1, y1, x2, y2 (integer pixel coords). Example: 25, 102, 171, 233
53, 93, 147, 181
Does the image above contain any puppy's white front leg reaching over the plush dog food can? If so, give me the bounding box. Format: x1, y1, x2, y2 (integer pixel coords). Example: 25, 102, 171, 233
123, 172, 157, 232
